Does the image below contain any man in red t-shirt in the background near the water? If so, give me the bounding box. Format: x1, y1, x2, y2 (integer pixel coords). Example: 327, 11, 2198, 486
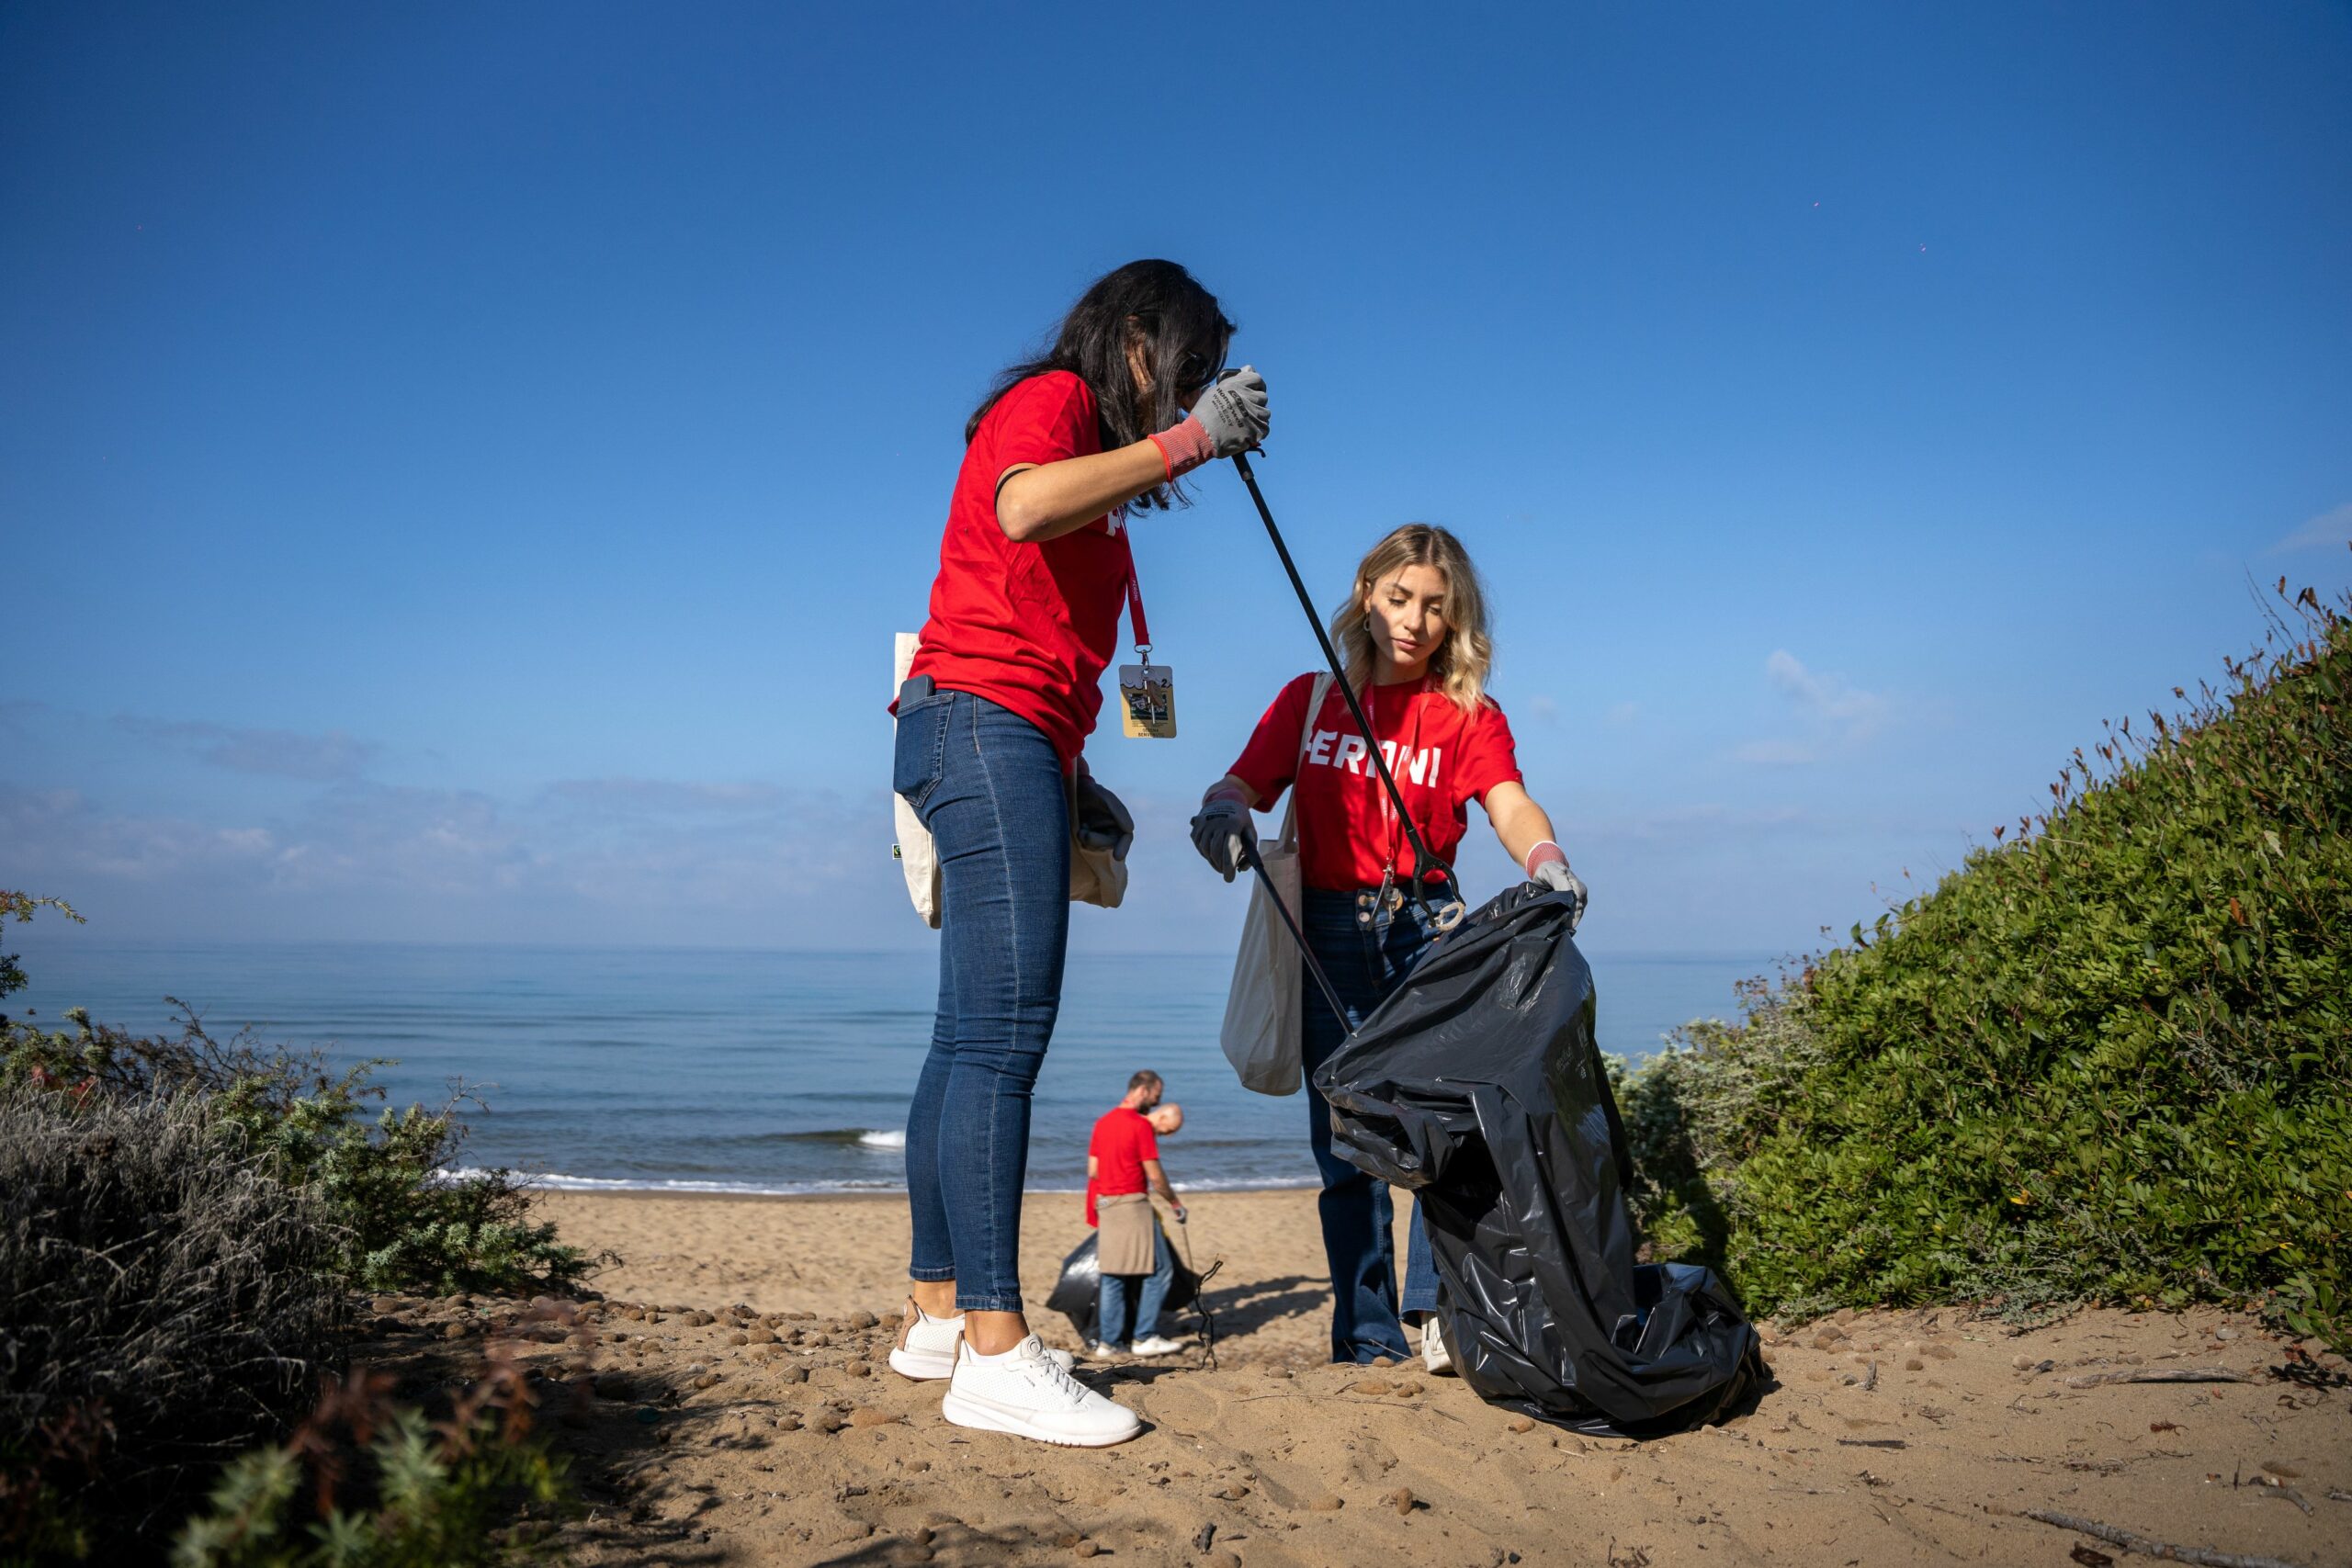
1087, 1067, 1183, 1357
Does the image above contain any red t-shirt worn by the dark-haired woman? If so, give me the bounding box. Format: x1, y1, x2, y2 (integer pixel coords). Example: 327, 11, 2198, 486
908, 371, 1129, 769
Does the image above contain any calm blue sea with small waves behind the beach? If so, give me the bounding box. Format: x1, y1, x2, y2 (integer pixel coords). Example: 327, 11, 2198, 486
5, 941, 1771, 1194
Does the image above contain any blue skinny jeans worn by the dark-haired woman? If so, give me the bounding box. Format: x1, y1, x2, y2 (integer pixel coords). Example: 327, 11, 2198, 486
891, 691, 1070, 1312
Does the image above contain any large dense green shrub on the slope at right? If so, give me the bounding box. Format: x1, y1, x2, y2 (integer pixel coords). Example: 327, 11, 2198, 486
1623, 583, 2352, 1342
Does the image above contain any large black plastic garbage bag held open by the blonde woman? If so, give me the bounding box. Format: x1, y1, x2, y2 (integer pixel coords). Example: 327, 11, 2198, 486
1315, 884, 1761, 1437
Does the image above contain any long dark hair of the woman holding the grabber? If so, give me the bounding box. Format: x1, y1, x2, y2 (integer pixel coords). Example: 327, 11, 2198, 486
965, 261, 1235, 505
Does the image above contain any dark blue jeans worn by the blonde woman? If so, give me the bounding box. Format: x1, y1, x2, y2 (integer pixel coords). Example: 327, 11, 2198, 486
1301, 888, 1437, 1361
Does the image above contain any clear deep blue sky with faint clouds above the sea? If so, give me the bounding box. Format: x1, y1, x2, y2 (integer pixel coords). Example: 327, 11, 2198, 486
0, 3, 2352, 952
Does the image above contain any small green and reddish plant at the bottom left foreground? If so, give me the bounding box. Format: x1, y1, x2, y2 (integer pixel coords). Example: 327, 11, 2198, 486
172, 1361, 571, 1568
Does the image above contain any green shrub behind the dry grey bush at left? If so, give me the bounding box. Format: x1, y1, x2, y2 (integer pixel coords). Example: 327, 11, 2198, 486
0, 1006, 591, 1293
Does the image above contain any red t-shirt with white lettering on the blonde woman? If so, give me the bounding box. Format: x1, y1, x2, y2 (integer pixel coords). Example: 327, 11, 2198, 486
1230, 674, 1520, 894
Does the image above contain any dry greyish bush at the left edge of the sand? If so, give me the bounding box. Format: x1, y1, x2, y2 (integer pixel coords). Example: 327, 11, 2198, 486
0, 1084, 348, 1559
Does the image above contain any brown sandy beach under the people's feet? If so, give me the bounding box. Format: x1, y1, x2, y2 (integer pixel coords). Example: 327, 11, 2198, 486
347, 1192, 2352, 1568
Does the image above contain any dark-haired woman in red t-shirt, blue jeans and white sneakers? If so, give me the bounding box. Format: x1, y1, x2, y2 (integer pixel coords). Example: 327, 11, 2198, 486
889, 261, 1268, 1446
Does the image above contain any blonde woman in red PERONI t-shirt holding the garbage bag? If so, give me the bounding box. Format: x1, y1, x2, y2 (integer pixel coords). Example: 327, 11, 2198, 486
1193, 522, 1585, 1371
